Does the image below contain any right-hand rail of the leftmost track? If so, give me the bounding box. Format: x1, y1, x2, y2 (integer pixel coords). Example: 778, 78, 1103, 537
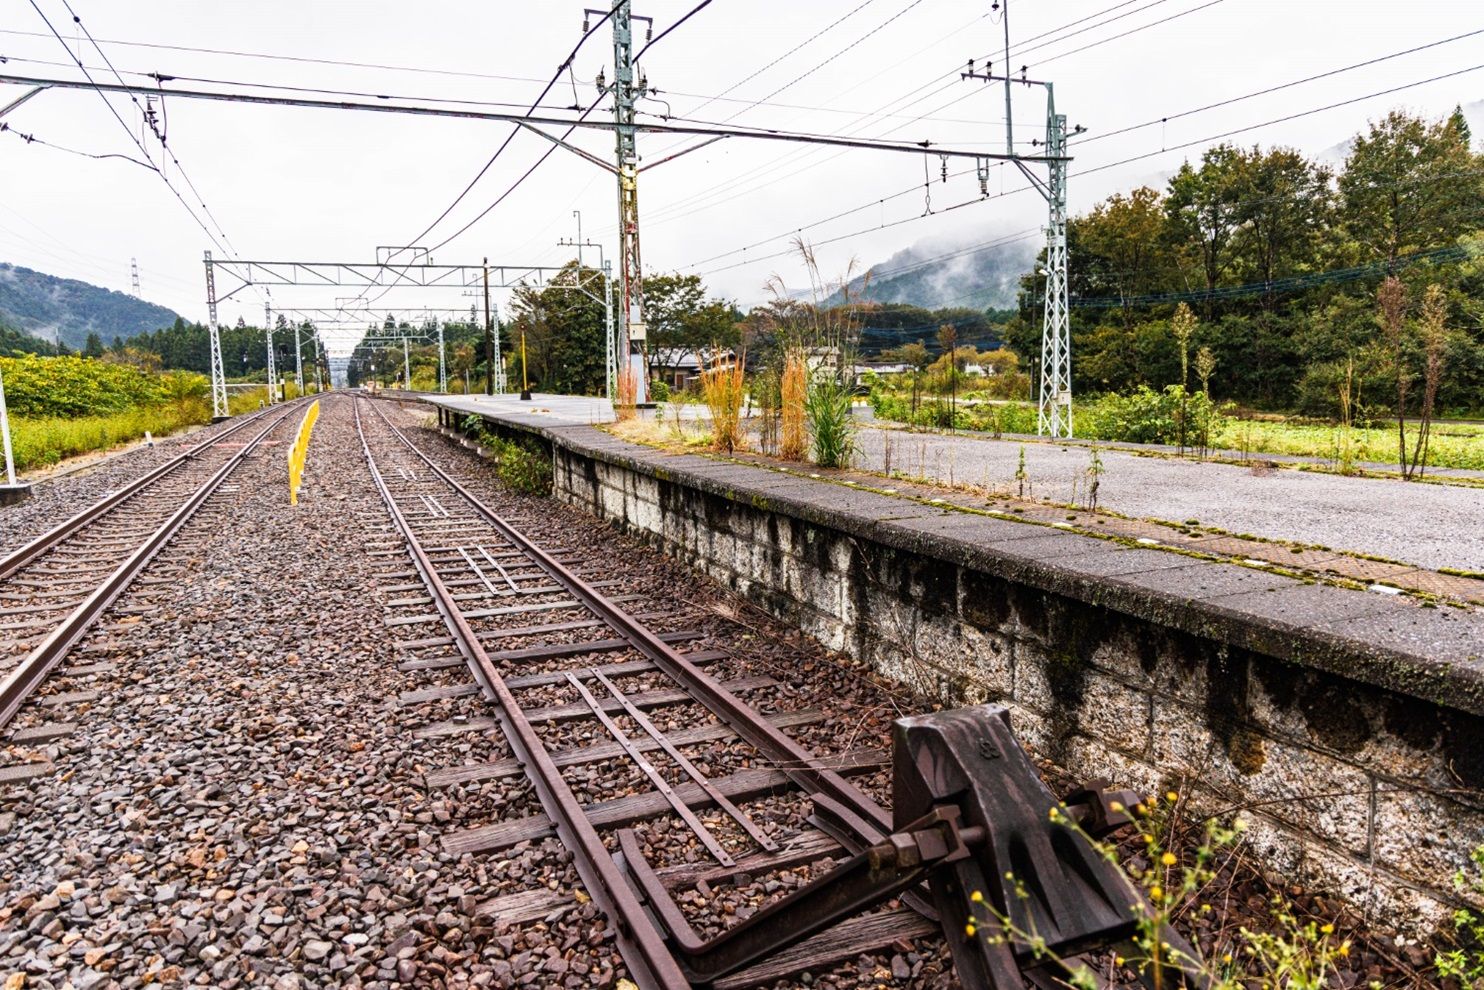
0, 408, 292, 729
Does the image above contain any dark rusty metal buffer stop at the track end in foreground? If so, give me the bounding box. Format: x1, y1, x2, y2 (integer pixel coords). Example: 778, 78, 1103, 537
619, 705, 1205, 990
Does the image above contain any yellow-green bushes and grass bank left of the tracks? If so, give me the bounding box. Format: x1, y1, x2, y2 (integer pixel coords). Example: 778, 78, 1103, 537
0, 355, 211, 471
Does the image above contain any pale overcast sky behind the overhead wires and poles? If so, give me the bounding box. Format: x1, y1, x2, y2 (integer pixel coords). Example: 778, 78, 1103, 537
0, 0, 1484, 351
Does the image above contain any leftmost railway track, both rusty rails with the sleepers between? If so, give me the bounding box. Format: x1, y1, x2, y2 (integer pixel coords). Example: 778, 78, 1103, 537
0, 404, 298, 729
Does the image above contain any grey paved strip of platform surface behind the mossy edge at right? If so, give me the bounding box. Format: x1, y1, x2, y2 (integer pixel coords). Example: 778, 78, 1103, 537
856, 427, 1484, 571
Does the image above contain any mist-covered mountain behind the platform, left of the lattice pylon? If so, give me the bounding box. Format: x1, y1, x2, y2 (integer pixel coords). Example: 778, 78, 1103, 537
830, 237, 1040, 309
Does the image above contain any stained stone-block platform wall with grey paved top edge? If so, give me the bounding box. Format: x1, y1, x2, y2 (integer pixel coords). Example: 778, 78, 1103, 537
439, 409, 1484, 931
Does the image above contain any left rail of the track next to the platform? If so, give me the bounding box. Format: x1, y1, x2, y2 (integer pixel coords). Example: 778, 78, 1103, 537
353, 396, 690, 990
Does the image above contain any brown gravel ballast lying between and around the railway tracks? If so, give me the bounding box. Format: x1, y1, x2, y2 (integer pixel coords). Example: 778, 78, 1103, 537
0, 395, 1424, 990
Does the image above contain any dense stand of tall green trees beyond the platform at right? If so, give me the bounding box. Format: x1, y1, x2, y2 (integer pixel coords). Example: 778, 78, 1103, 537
1006, 111, 1484, 416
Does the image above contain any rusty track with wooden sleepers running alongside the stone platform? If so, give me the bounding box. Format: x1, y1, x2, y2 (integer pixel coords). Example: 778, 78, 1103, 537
355, 399, 938, 987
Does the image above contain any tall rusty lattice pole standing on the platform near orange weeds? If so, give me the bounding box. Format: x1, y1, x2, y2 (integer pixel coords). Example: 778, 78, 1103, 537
598, 0, 653, 402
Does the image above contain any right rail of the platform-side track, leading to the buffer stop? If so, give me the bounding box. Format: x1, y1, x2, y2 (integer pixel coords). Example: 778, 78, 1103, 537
362, 397, 892, 852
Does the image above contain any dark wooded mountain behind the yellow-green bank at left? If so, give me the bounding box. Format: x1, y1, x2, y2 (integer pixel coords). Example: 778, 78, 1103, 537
0, 261, 177, 350
